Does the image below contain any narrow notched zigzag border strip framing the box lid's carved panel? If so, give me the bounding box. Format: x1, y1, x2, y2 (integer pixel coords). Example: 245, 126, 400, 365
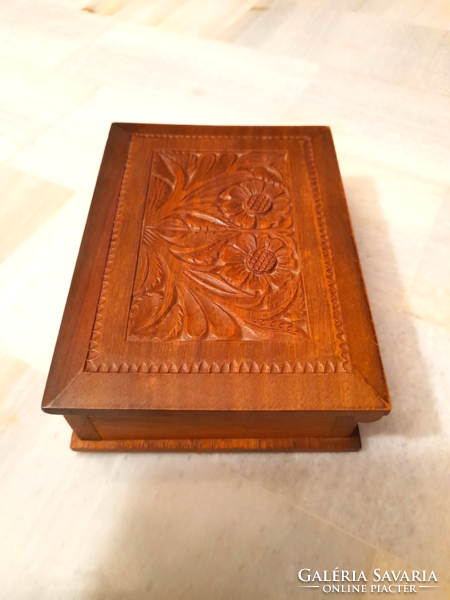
84, 133, 351, 374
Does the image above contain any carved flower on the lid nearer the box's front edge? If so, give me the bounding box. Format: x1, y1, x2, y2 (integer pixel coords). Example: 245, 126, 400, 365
220, 234, 298, 292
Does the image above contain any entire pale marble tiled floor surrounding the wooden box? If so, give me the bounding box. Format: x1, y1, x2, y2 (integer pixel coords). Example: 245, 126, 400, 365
0, 0, 450, 600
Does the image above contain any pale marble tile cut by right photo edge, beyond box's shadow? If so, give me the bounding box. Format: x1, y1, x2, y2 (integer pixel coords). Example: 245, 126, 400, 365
402, 195, 450, 329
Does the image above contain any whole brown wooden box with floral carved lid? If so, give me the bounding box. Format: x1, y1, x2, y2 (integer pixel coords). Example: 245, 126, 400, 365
42, 124, 390, 451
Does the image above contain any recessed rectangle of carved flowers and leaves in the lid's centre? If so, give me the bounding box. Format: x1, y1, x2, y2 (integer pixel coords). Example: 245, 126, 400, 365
127, 151, 308, 341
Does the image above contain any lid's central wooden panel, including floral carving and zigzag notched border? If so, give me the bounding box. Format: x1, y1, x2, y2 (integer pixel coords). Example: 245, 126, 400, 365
85, 133, 351, 374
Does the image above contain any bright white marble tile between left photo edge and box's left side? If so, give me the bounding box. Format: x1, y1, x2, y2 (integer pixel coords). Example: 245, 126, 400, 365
0, 192, 90, 372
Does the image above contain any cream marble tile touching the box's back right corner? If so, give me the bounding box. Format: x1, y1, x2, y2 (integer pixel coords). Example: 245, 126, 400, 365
282, 68, 450, 184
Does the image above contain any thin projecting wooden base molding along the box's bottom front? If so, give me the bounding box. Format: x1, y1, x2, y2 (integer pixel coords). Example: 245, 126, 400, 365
70, 427, 361, 452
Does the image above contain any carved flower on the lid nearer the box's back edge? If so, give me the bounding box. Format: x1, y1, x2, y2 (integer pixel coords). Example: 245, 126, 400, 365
220, 179, 289, 229
